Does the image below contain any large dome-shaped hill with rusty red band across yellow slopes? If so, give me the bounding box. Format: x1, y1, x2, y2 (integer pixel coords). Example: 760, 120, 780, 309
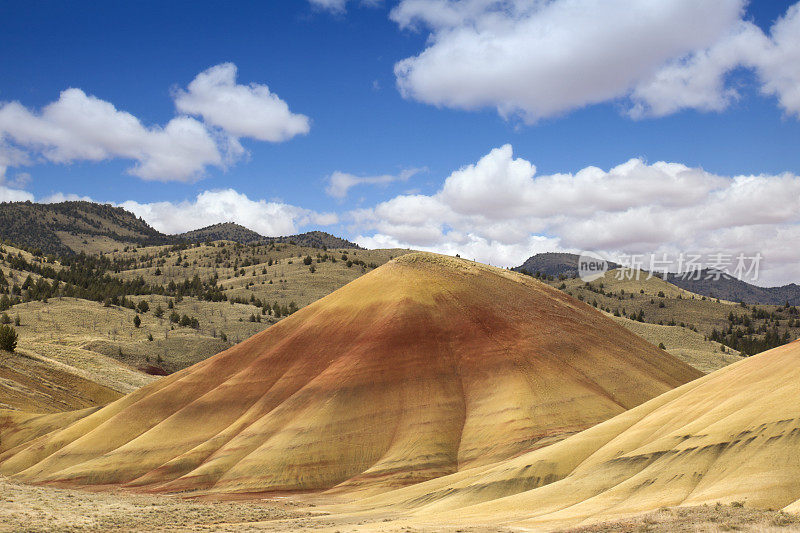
0, 253, 701, 493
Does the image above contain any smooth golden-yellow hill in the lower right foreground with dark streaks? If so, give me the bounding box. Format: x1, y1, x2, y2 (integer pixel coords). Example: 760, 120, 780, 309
361, 342, 800, 528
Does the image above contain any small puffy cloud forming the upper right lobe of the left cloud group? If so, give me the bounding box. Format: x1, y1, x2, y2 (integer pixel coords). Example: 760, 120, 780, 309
174, 63, 310, 142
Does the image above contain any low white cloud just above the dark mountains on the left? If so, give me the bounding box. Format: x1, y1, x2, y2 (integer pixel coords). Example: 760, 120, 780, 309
119, 189, 338, 237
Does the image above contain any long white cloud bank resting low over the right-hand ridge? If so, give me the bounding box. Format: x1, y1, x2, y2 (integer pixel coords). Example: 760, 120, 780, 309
349, 145, 800, 283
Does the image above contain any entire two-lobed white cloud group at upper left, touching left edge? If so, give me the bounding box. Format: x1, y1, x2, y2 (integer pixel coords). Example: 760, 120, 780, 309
0, 63, 309, 182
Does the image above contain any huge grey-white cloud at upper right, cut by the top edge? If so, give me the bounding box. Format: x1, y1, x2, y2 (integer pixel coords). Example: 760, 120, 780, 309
391, 0, 800, 122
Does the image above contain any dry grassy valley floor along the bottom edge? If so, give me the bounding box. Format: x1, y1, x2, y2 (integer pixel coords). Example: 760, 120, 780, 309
0, 477, 800, 533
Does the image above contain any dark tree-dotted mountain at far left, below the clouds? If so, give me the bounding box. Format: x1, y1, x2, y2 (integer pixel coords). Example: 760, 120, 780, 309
0, 201, 172, 255
